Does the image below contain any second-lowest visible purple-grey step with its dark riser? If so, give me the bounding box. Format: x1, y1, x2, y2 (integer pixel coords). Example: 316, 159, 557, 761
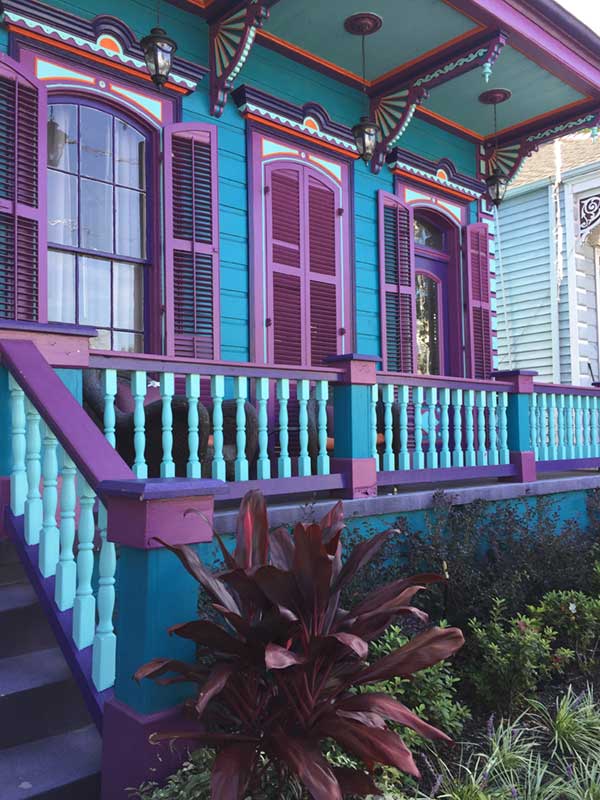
0, 647, 90, 750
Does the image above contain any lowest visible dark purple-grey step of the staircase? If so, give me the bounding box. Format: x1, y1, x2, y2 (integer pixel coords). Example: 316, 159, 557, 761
0, 725, 102, 800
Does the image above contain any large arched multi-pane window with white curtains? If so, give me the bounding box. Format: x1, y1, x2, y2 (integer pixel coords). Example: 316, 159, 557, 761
47, 102, 151, 352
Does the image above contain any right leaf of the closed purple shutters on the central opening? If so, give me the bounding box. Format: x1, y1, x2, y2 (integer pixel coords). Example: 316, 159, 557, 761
306, 172, 341, 367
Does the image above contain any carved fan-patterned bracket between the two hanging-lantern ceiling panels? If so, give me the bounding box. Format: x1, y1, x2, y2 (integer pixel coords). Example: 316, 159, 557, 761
371, 32, 508, 172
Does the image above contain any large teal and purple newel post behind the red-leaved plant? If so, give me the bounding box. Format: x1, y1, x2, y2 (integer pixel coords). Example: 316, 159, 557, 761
98, 478, 223, 800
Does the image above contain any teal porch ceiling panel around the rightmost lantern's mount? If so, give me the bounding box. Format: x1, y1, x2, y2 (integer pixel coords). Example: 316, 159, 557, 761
424, 45, 584, 136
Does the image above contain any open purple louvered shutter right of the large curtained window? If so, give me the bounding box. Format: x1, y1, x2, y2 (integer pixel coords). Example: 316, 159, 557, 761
164, 123, 219, 359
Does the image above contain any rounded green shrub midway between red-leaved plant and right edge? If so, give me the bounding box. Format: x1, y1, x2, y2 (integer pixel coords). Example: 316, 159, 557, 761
467, 598, 573, 711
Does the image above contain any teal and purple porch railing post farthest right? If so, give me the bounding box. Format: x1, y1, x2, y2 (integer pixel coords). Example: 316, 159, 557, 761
492, 369, 538, 483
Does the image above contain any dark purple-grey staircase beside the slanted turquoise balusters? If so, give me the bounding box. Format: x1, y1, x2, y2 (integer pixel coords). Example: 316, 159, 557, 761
0, 540, 102, 800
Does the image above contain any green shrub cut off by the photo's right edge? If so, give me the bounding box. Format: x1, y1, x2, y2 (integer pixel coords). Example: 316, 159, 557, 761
528, 591, 600, 672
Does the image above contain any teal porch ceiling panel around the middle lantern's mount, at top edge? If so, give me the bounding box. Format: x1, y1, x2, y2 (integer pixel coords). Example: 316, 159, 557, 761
265, 0, 476, 80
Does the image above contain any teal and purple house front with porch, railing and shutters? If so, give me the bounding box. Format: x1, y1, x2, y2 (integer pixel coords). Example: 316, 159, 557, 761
0, 0, 600, 800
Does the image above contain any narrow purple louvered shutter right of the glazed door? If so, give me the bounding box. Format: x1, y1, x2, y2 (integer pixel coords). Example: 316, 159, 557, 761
464, 222, 492, 380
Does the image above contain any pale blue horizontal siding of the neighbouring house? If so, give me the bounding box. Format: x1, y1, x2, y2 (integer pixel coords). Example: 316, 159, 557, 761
496, 186, 552, 381
